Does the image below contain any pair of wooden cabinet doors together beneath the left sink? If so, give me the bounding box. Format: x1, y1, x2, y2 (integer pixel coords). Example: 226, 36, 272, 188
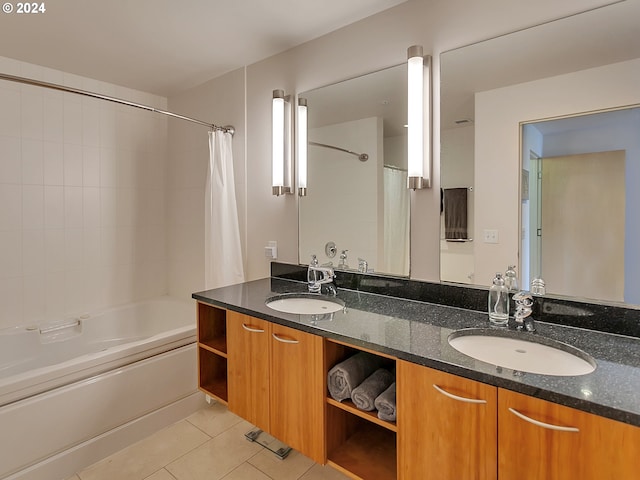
227, 311, 325, 463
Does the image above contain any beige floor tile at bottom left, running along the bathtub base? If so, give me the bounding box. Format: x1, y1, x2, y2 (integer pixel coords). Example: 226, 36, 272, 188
78, 420, 210, 480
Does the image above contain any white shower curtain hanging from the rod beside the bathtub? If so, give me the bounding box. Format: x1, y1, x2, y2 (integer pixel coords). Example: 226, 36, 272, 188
204, 130, 244, 289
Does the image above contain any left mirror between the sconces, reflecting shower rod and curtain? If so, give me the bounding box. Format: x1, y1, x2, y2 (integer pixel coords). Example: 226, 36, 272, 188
299, 65, 409, 276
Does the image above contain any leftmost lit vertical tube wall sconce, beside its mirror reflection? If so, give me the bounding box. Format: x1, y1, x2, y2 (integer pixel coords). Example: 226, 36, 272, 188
271, 90, 292, 196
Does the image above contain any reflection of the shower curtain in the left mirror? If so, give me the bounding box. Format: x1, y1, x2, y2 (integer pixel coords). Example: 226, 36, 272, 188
380, 166, 409, 275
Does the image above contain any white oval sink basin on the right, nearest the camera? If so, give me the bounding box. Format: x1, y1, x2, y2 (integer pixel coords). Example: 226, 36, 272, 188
448, 329, 596, 376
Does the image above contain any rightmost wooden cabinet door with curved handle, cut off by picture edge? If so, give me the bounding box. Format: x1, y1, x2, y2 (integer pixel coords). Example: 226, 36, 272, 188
498, 389, 640, 480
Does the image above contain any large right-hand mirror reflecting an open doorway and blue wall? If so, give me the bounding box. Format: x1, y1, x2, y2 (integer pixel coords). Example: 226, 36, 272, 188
440, 2, 640, 305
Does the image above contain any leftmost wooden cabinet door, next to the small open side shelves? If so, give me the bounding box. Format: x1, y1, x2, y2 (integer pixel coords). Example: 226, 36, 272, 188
227, 311, 271, 432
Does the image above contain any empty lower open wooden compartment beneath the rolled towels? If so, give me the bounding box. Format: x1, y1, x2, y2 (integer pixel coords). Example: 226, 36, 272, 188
327, 405, 397, 480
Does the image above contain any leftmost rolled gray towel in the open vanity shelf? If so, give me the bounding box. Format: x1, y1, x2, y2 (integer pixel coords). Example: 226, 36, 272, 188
327, 352, 385, 402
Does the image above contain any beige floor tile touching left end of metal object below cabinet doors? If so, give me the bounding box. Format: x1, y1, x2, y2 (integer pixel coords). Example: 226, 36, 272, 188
166, 421, 262, 480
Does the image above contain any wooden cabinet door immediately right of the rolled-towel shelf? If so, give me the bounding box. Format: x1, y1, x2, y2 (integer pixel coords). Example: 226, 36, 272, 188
396, 361, 498, 480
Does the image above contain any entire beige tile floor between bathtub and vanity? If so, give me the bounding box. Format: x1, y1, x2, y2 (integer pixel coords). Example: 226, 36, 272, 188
69, 404, 348, 480
